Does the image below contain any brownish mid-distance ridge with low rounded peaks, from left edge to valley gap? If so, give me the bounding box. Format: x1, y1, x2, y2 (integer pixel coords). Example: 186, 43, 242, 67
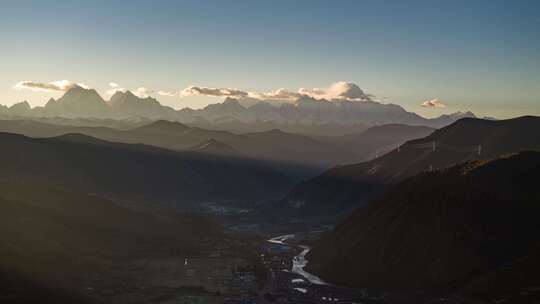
0, 120, 353, 167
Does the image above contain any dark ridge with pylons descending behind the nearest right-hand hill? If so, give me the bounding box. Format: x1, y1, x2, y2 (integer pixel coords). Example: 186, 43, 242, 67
282, 116, 540, 216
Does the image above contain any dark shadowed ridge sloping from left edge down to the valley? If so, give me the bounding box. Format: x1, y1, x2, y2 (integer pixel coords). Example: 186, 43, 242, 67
0, 133, 293, 207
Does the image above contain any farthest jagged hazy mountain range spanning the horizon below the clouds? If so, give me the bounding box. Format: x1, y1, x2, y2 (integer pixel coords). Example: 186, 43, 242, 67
0, 86, 474, 135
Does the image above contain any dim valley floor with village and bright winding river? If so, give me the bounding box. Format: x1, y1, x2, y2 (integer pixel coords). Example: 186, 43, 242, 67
78, 222, 381, 304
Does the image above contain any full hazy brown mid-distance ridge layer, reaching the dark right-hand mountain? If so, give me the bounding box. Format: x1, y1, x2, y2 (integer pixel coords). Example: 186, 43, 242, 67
0, 120, 431, 169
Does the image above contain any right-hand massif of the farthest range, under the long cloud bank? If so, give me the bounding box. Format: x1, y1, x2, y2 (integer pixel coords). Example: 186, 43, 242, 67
181, 96, 475, 127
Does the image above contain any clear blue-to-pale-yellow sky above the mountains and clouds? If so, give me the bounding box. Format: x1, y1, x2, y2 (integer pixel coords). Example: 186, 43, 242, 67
0, 0, 540, 118
